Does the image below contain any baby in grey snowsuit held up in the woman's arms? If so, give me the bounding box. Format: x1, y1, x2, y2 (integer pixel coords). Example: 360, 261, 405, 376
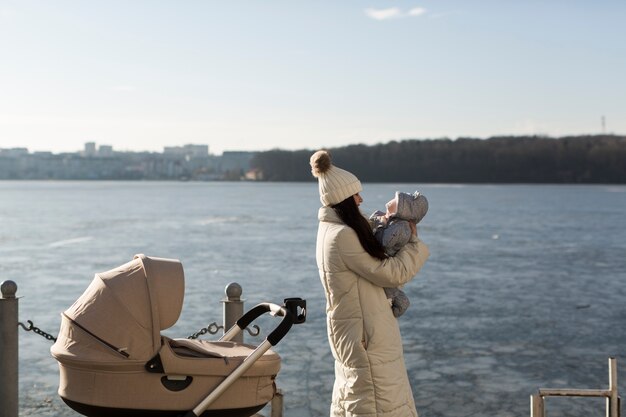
370, 191, 428, 317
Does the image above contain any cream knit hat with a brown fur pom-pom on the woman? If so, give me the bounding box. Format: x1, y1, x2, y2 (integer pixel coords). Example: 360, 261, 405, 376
310, 150, 363, 207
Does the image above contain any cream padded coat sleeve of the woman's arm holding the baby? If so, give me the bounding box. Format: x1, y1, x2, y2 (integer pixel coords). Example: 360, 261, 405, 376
337, 228, 429, 287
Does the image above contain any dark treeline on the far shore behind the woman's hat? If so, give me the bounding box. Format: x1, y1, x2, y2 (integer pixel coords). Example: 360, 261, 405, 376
251, 135, 626, 184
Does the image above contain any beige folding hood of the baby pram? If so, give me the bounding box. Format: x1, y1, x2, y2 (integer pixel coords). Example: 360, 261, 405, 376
51, 254, 185, 364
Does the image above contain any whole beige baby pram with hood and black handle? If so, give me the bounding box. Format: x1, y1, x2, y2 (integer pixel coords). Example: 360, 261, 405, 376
51, 255, 306, 417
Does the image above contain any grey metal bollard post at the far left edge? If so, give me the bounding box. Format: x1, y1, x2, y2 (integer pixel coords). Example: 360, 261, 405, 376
0, 281, 19, 417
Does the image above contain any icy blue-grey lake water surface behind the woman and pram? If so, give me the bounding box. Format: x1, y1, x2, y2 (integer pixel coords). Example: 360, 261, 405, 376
0, 182, 626, 417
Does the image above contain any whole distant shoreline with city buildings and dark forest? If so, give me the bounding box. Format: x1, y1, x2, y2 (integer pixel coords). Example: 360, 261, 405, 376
0, 135, 626, 184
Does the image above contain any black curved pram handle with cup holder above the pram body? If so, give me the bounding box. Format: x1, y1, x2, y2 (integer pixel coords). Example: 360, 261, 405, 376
220, 298, 306, 346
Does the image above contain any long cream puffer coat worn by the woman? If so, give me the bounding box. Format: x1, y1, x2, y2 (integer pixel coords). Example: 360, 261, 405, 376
316, 207, 429, 417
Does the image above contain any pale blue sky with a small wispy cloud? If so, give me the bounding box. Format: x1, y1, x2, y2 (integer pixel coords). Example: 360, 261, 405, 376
0, 0, 626, 154
